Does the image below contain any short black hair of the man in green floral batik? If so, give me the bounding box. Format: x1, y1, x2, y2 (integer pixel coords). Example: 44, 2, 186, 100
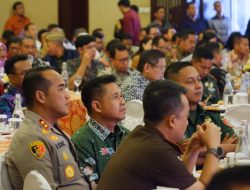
81, 75, 116, 115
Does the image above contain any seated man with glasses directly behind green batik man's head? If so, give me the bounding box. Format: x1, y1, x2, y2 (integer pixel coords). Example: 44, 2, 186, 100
98, 43, 133, 86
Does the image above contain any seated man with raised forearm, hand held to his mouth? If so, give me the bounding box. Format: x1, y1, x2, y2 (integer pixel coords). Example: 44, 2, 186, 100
67, 35, 104, 89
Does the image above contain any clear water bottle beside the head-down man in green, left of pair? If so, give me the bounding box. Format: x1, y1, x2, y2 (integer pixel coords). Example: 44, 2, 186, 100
223, 73, 233, 106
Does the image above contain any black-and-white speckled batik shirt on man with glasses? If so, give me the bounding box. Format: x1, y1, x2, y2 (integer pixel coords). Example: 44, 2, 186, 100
121, 71, 149, 102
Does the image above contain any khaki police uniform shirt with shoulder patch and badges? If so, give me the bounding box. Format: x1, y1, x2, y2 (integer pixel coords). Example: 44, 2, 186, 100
6, 110, 89, 190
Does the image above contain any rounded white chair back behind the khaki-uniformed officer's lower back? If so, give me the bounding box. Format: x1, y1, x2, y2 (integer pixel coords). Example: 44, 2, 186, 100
23, 170, 52, 190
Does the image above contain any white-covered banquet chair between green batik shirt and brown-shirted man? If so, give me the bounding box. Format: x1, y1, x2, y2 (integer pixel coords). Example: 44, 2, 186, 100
122, 100, 144, 131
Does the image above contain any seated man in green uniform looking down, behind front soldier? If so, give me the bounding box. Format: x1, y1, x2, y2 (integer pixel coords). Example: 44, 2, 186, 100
192, 47, 220, 105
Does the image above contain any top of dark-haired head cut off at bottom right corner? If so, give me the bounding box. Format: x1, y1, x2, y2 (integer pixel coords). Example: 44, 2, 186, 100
206, 166, 250, 190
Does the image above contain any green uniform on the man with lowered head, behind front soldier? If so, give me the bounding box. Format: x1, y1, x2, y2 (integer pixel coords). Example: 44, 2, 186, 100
201, 74, 220, 105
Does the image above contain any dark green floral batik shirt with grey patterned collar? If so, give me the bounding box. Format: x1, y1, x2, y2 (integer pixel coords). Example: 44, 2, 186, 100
72, 119, 128, 182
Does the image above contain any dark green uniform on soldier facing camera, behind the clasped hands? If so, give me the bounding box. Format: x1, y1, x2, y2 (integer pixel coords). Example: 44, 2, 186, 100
185, 105, 234, 140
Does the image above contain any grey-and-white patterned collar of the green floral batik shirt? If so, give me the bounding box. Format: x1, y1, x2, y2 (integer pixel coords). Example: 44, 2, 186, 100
88, 118, 122, 141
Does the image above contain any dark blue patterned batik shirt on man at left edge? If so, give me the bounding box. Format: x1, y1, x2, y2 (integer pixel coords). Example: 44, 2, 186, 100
0, 86, 26, 118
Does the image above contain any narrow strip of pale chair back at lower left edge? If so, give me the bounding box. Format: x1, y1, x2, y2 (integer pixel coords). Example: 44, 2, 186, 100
0, 155, 13, 190
